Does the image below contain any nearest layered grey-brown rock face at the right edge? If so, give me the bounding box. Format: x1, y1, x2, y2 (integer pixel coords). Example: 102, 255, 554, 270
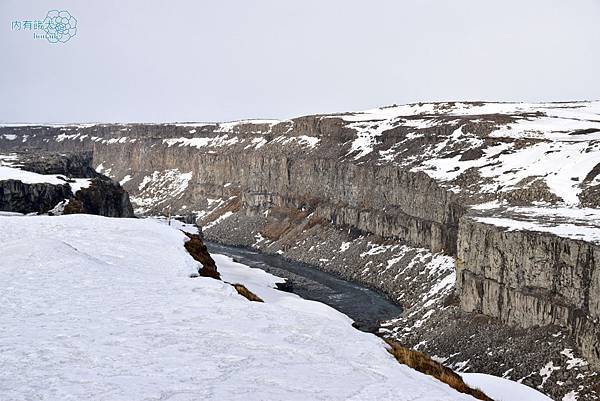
456, 218, 600, 361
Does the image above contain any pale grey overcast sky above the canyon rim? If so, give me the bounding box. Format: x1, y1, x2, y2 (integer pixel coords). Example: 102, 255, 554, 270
0, 0, 600, 122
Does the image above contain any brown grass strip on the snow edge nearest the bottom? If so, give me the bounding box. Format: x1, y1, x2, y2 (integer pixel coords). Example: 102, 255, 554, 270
384, 339, 494, 401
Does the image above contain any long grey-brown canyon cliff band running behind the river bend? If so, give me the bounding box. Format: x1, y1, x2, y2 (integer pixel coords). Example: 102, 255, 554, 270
0, 117, 465, 254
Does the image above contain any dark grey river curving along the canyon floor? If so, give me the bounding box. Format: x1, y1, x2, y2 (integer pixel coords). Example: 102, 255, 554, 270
205, 241, 402, 331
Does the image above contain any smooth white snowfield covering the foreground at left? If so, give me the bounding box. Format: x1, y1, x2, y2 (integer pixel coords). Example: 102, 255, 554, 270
0, 215, 482, 401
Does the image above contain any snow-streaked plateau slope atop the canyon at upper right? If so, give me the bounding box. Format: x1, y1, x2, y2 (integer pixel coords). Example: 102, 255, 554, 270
327, 101, 600, 206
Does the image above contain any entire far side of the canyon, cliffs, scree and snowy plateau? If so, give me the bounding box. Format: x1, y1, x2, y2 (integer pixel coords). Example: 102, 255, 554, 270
0, 102, 600, 399
